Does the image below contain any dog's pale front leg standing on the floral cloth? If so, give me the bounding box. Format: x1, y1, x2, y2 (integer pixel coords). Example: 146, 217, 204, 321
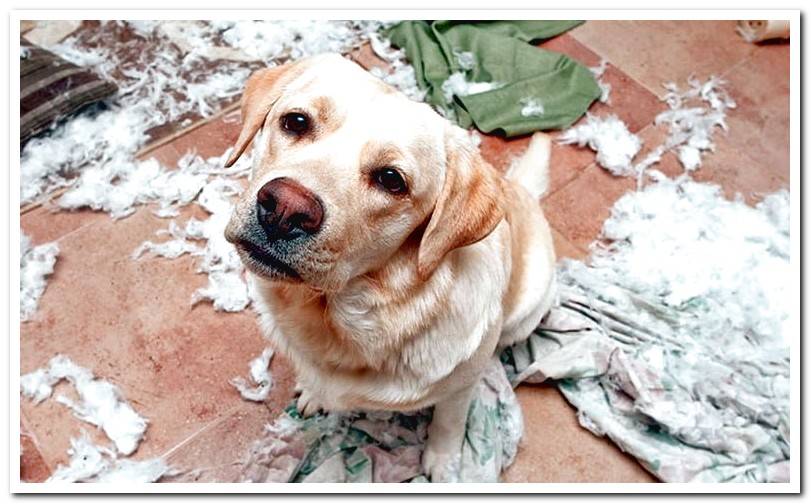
422, 382, 476, 483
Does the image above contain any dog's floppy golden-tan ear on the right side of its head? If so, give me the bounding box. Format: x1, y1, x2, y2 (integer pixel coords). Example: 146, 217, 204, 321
417, 131, 504, 280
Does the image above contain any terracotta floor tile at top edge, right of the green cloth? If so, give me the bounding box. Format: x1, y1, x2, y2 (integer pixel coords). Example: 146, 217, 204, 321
570, 20, 755, 96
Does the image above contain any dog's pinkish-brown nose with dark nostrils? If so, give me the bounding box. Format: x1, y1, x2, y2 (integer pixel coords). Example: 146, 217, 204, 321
256, 177, 324, 240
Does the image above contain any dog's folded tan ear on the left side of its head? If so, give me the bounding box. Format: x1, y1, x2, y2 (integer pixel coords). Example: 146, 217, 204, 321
225, 63, 300, 167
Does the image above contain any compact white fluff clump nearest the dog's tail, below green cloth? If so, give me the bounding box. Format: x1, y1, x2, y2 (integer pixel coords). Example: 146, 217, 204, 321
558, 114, 642, 176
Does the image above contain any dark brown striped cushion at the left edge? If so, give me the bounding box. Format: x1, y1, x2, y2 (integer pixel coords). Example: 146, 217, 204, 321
20, 38, 118, 144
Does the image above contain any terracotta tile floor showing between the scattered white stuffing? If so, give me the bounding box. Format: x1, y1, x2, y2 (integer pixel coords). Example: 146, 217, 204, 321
20, 21, 789, 482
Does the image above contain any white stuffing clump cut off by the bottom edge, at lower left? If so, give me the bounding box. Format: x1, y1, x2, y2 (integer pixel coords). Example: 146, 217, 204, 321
46, 431, 171, 483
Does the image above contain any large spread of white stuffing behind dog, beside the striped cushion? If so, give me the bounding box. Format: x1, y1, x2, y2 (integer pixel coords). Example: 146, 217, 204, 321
20, 20, 406, 204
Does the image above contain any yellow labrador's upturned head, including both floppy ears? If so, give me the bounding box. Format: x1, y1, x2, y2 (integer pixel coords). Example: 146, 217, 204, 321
225, 55, 503, 291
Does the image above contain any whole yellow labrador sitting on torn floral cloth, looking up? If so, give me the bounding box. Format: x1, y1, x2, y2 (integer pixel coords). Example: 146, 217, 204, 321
226, 55, 556, 481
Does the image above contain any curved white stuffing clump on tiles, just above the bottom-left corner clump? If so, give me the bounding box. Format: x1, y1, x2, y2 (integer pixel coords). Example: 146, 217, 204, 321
20, 355, 148, 455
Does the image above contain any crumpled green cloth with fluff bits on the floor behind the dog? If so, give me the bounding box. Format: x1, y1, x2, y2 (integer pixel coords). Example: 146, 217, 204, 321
386, 21, 600, 136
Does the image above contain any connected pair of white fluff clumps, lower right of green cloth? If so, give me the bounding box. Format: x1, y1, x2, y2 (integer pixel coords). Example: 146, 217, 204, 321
559, 77, 736, 185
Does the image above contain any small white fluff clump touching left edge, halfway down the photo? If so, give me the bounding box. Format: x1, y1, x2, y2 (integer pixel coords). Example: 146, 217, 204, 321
20, 232, 59, 321
